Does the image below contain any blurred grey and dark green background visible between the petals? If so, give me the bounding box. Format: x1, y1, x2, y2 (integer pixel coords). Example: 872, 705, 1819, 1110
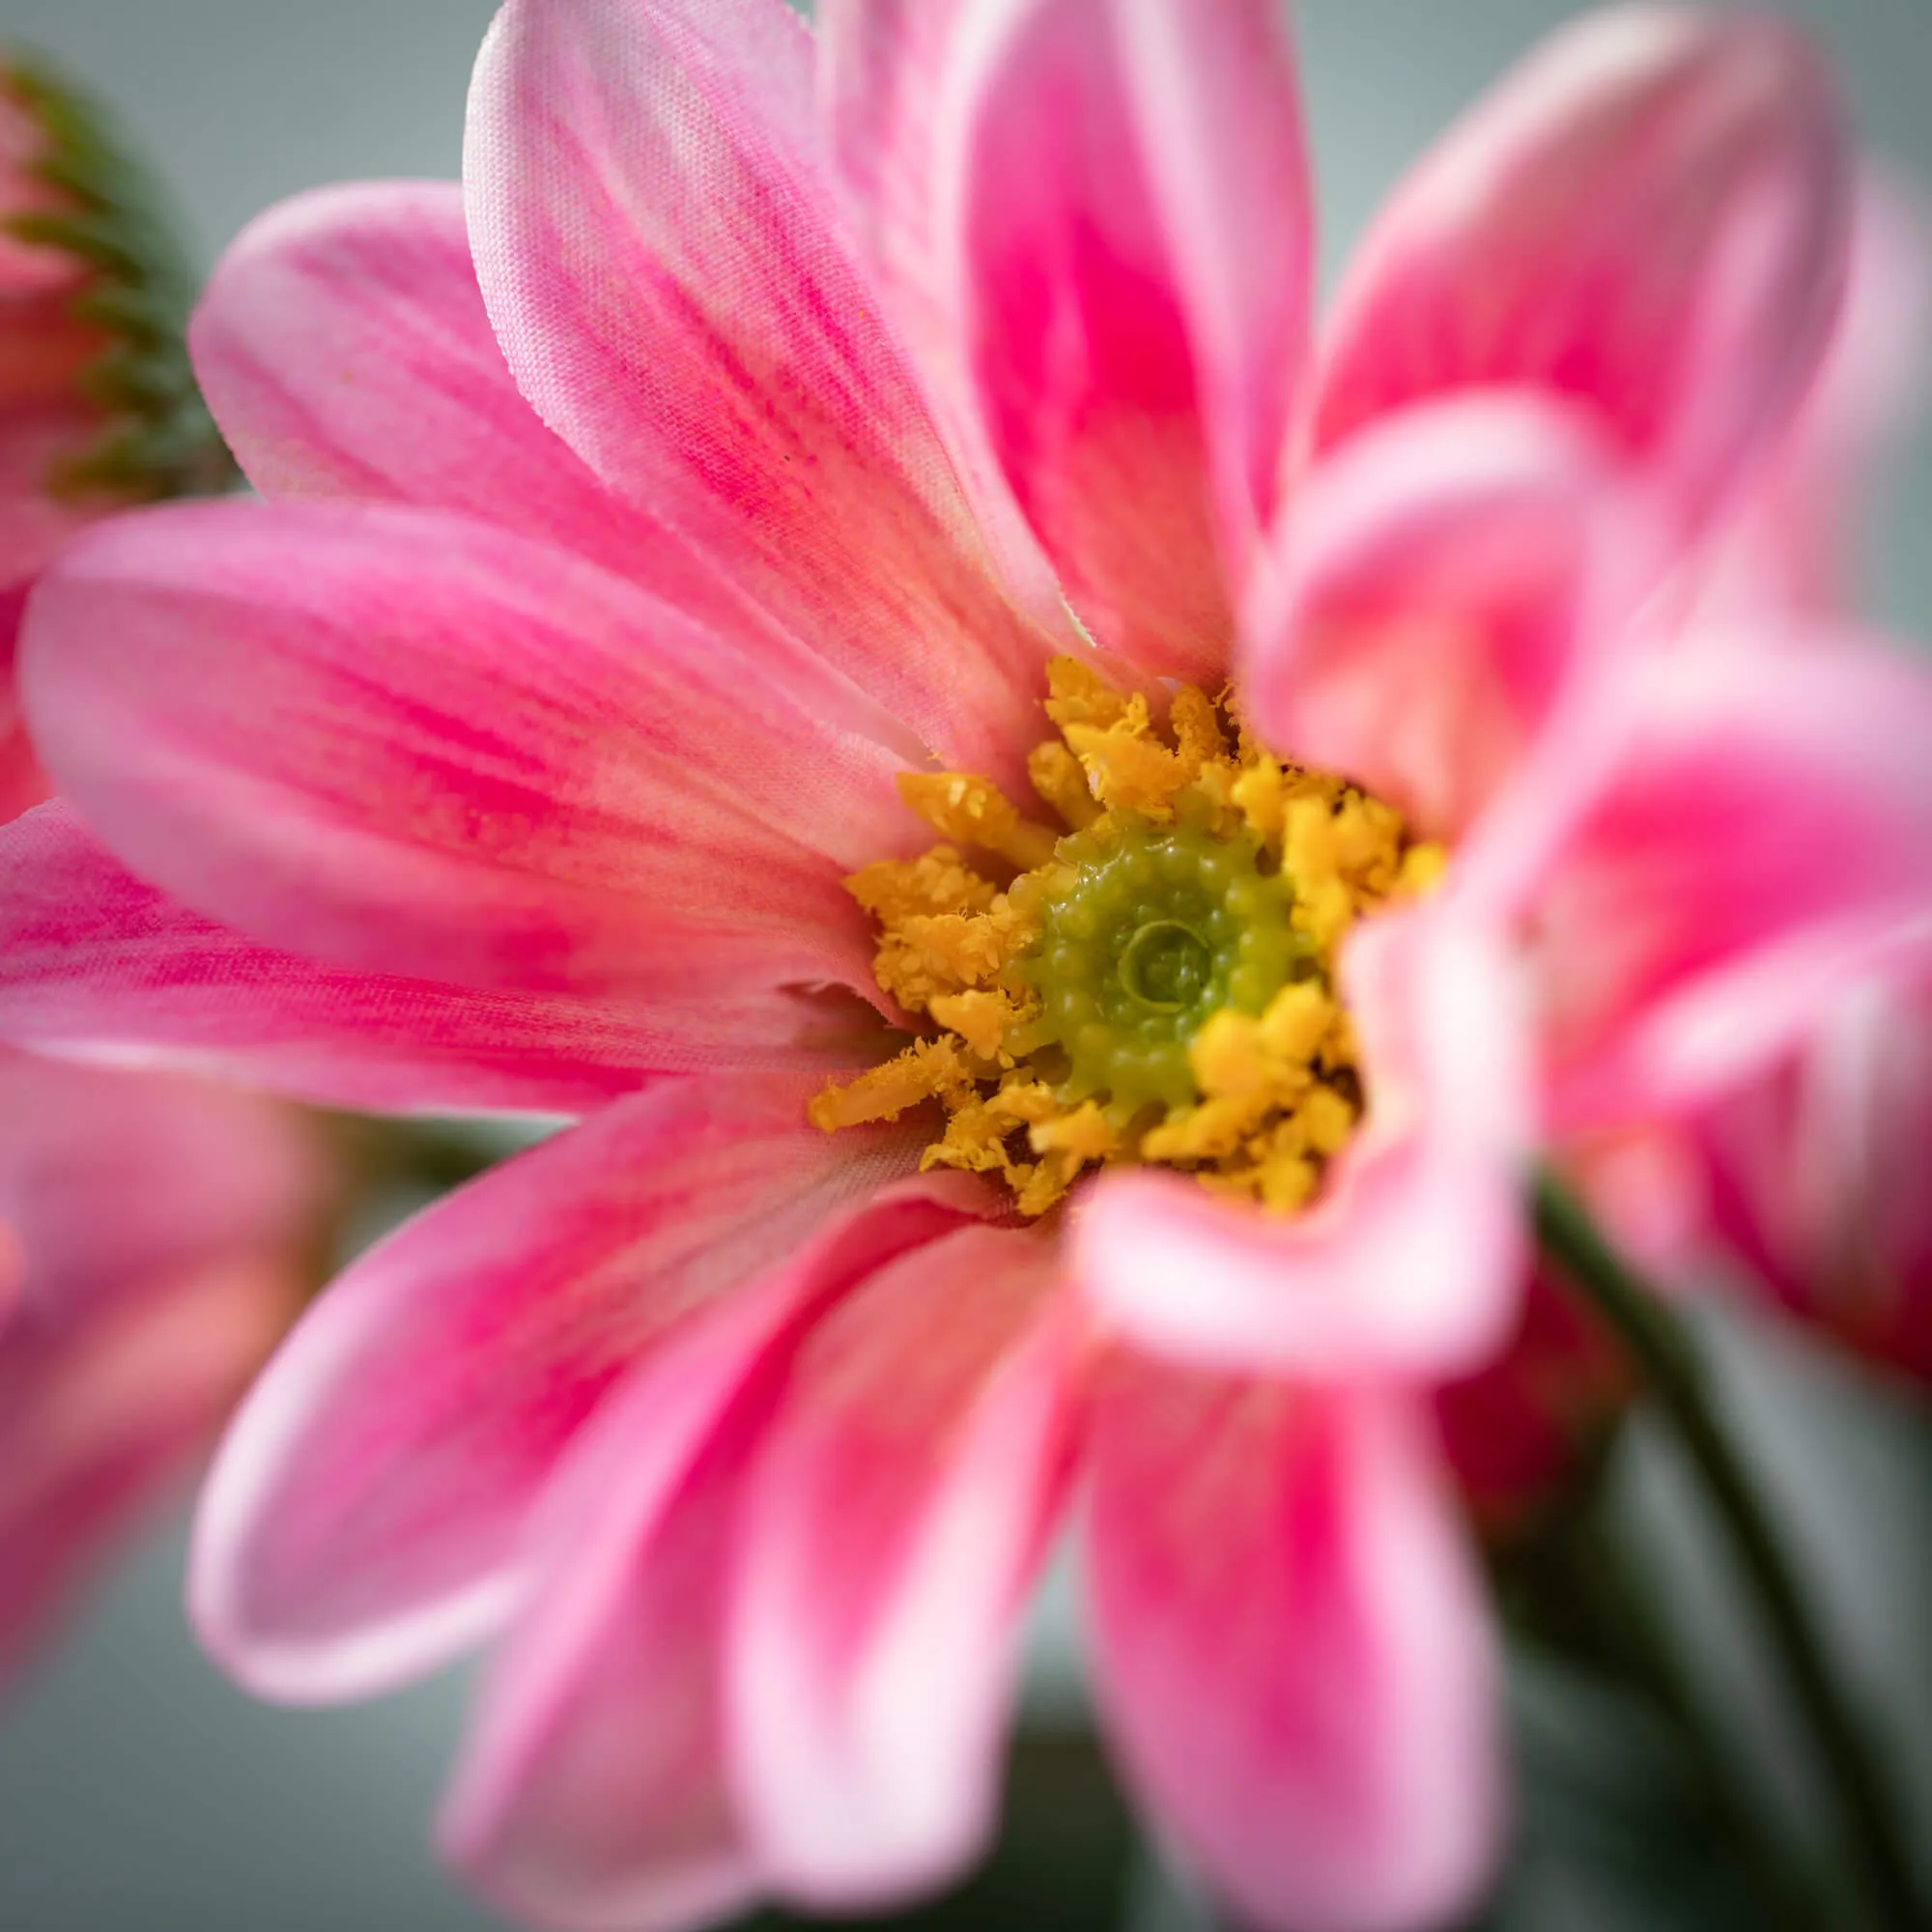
0, 0, 1932, 1932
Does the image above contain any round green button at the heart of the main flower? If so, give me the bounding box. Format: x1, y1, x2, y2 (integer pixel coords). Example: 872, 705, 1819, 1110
1020, 815, 1312, 1121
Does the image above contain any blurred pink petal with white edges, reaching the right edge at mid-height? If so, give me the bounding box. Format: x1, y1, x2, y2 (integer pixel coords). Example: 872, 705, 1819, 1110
1534, 636, 1932, 1132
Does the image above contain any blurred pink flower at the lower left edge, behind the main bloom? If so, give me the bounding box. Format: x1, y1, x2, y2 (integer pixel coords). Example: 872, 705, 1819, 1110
0, 1051, 325, 1681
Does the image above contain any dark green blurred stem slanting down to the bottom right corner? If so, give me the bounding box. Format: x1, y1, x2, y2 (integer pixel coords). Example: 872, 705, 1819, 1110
1536, 1173, 1928, 1932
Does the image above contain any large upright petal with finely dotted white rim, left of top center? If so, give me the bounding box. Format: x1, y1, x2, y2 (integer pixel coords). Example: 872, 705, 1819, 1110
466, 0, 1051, 775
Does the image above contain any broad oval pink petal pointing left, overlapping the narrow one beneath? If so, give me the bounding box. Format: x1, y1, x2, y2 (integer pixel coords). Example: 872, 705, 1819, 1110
21, 504, 910, 1003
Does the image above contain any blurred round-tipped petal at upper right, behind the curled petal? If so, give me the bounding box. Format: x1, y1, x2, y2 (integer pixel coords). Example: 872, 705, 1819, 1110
1314, 6, 1851, 516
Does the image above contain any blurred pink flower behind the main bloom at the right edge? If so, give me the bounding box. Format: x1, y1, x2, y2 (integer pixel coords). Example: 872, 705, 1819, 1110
1638, 182, 1932, 1379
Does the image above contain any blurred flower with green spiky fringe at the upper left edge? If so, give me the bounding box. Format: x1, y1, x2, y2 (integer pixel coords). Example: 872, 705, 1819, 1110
0, 46, 234, 823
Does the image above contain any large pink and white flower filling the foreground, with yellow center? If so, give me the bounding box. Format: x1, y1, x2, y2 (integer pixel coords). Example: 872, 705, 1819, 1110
0, 0, 1932, 1932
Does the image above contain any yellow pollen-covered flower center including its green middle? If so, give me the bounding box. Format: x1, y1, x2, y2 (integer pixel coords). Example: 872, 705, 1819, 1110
811, 659, 1445, 1215
